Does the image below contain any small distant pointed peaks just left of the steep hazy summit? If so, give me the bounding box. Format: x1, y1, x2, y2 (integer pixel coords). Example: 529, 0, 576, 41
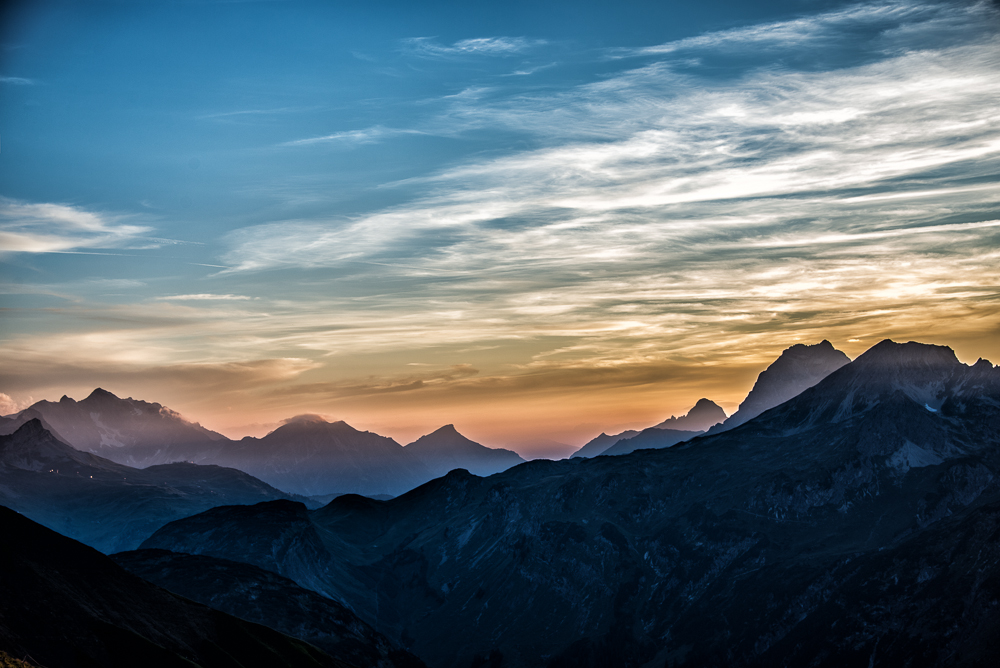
573, 399, 726, 457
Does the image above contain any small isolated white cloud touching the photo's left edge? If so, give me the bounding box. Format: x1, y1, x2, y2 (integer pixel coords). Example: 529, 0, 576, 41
0, 197, 152, 253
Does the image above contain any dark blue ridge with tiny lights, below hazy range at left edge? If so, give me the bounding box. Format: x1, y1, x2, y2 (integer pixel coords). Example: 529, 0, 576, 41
0, 419, 305, 552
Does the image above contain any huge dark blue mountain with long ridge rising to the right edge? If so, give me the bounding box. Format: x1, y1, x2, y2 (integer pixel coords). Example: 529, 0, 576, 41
144, 341, 1000, 668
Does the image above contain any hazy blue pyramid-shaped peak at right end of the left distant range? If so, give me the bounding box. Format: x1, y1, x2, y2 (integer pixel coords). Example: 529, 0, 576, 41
406, 424, 524, 477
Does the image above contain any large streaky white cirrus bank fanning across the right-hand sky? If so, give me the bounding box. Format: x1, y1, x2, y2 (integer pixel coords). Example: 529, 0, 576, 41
224, 3, 1000, 376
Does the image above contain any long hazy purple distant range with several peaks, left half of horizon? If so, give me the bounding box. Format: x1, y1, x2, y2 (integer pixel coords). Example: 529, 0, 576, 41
0, 396, 524, 496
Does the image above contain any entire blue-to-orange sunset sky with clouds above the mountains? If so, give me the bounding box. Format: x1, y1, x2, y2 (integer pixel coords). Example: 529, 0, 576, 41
0, 0, 1000, 456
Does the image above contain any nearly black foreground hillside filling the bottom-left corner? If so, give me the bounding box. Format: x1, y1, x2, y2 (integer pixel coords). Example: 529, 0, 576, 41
0, 507, 349, 668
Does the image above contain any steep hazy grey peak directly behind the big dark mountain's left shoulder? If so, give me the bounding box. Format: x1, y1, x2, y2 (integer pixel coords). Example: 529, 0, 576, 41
710, 339, 851, 434
